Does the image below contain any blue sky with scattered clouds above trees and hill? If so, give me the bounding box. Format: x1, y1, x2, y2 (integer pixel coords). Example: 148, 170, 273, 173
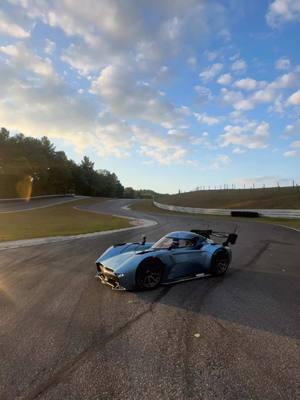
0, 0, 300, 192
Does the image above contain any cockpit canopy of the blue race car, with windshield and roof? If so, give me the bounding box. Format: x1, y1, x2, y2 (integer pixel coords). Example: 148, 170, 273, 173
152, 231, 206, 249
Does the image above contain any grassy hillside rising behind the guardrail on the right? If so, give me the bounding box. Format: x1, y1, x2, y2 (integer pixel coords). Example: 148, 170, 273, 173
156, 187, 300, 209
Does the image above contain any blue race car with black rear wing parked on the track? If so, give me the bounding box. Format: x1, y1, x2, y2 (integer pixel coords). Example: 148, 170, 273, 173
96, 230, 237, 290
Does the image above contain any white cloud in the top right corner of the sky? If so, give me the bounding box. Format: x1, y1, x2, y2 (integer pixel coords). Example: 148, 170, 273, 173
266, 0, 300, 28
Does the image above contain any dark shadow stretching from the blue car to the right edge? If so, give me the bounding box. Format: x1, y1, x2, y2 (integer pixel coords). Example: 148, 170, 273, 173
129, 269, 300, 338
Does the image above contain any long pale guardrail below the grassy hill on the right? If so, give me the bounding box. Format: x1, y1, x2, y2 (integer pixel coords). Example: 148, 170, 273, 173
153, 201, 300, 219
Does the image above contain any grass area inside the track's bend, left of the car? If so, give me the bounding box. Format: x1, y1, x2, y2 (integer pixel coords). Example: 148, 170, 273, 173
0, 198, 130, 241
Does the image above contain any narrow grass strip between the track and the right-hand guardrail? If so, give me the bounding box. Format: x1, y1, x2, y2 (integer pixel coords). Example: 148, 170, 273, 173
130, 200, 300, 229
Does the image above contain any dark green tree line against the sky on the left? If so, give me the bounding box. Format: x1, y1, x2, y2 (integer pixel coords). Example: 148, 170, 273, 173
0, 128, 131, 198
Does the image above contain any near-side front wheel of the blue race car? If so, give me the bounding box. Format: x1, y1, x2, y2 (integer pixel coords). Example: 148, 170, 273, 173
136, 258, 163, 290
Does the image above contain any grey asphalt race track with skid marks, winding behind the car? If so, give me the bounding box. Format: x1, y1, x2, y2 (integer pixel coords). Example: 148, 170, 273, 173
0, 200, 300, 400
